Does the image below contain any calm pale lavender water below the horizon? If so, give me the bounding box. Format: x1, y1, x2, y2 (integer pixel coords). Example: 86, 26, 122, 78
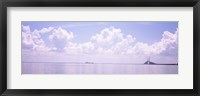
22, 63, 178, 74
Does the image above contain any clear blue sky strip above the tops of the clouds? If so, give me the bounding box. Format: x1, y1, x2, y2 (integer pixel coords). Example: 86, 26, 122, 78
22, 21, 178, 43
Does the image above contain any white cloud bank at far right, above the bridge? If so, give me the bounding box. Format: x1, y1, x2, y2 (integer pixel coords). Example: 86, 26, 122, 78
127, 28, 178, 57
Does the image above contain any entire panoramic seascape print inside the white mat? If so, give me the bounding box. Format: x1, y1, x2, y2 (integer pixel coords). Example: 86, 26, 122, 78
21, 21, 178, 74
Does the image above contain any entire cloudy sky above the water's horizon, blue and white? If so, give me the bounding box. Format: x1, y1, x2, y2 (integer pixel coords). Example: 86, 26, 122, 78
21, 21, 178, 64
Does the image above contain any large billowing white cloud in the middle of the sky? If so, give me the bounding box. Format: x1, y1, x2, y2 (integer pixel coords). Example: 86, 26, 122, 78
64, 26, 136, 55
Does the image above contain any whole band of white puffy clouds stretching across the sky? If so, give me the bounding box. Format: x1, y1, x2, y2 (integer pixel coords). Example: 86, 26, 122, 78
22, 25, 178, 62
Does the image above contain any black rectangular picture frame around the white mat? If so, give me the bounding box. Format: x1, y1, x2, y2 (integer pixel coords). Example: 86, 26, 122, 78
0, 0, 200, 96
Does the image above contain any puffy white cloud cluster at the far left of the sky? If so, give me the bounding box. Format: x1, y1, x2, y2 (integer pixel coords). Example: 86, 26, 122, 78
22, 25, 74, 52
